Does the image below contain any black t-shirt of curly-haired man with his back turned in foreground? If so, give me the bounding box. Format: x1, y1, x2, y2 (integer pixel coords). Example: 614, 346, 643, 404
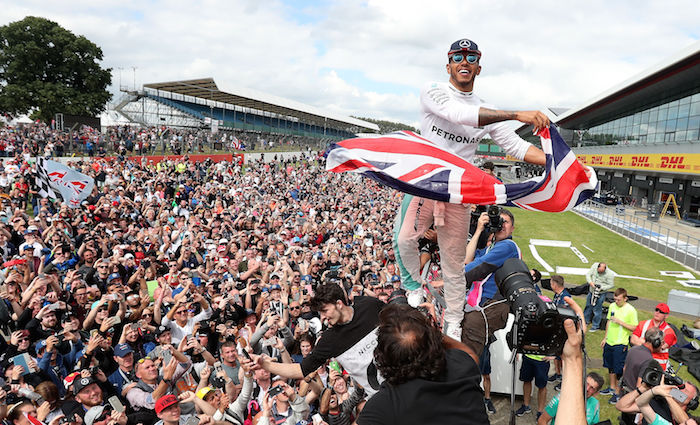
357, 349, 489, 425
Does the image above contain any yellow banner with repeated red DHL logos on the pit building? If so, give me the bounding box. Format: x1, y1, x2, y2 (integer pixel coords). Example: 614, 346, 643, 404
576, 153, 700, 174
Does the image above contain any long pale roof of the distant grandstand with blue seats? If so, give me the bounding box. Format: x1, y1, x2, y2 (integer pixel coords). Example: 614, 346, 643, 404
143, 78, 379, 131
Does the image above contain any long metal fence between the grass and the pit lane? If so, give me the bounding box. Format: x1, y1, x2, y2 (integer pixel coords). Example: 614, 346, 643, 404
574, 200, 700, 271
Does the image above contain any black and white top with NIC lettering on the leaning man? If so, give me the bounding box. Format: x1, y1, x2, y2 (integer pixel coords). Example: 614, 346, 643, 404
301, 297, 386, 397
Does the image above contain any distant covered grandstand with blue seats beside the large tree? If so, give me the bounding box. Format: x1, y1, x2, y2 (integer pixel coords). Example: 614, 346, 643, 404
114, 78, 379, 145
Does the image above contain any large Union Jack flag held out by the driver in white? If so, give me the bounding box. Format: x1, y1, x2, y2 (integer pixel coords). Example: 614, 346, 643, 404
326, 126, 598, 212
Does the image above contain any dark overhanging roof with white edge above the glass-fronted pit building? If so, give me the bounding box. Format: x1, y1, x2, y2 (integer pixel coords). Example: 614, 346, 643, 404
556, 41, 700, 129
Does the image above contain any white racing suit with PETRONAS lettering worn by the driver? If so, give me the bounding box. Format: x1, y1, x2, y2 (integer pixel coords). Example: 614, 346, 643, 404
394, 82, 531, 324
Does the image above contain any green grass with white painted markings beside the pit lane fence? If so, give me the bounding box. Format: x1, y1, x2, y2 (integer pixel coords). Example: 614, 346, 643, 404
511, 209, 700, 423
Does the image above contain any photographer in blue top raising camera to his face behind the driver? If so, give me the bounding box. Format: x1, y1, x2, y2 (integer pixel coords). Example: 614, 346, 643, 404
462, 207, 521, 355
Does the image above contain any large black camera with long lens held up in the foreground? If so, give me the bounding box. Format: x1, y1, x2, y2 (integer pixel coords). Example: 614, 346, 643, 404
494, 258, 579, 356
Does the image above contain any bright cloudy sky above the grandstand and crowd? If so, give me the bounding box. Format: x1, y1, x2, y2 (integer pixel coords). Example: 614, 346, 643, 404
0, 0, 700, 126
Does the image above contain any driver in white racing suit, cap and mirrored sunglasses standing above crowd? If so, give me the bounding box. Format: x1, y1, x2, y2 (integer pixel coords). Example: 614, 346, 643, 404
394, 38, 549, 339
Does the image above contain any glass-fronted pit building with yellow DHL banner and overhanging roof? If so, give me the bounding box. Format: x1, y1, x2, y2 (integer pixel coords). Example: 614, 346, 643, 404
517, 42, 700, 217
